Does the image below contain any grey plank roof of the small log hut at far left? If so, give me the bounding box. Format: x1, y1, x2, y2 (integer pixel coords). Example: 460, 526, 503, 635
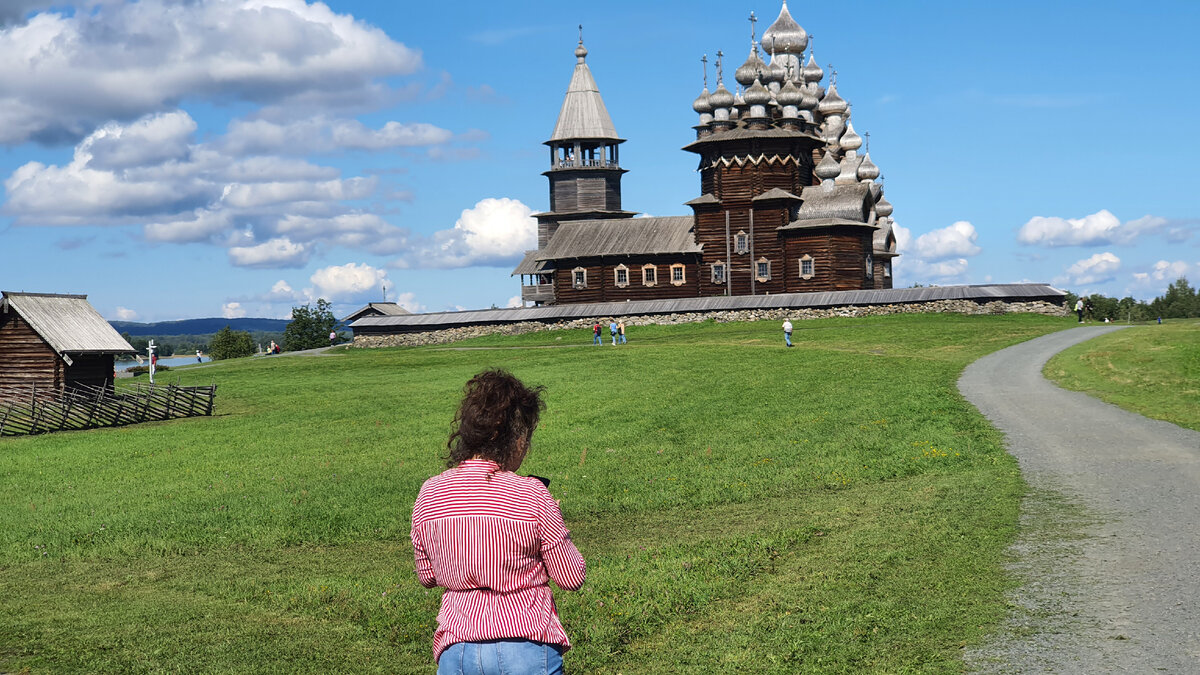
0, 291, 136, 356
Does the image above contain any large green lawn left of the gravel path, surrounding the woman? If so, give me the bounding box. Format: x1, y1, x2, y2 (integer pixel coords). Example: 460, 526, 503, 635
0, 315, 1073, 673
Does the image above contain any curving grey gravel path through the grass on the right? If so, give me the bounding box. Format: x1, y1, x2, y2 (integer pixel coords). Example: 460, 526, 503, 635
959, 327, 1200, 673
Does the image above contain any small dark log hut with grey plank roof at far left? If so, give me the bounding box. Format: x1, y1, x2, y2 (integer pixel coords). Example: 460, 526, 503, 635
0, 291, 136, 398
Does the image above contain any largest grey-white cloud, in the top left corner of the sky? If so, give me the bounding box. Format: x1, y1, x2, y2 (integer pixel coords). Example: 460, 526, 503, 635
0, 0, 421, 144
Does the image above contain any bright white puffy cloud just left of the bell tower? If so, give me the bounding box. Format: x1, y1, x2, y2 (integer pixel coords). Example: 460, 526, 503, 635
403, 197, 538, 268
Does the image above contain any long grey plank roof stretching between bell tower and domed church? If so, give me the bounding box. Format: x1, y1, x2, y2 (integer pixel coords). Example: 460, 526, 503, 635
534, 216, 701, 261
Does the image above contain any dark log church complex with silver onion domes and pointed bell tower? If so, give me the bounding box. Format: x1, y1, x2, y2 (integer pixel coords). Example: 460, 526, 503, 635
512, 1, 896, 305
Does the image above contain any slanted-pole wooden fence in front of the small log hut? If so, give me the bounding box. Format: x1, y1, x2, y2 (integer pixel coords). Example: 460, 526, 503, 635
0, 384, 217, 436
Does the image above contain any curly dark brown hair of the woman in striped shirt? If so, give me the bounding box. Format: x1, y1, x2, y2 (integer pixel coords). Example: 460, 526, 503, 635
446, 368, 546, 468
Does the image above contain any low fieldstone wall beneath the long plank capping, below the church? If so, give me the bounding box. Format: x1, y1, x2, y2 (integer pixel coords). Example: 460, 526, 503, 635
350, 300, 1068, 348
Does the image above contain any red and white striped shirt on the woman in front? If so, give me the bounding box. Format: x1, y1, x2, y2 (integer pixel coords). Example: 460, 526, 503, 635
412, 459, 586, 661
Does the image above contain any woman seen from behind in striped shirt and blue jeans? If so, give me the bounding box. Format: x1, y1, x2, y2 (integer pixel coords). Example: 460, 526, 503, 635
412, 370, 587, 675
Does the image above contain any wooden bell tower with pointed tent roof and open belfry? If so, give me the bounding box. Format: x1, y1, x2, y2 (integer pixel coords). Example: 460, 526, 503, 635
535, 26, 634, 250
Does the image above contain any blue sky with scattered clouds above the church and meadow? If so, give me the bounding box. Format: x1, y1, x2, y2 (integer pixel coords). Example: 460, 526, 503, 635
0, 0, 1200, 322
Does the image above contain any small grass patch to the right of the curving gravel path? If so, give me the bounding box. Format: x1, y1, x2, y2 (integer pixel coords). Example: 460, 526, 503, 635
1044, 318, 1200, 431
